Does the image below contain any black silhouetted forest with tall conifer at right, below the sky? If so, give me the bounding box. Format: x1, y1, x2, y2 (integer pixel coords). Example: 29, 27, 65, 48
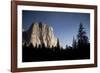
22, 23, 90, 62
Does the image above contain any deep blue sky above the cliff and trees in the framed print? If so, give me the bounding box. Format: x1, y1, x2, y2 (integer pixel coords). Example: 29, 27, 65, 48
22, 10, 90, 47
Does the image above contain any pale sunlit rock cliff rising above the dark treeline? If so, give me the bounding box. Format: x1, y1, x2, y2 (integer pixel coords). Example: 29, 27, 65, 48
22, 22, 57, 48
